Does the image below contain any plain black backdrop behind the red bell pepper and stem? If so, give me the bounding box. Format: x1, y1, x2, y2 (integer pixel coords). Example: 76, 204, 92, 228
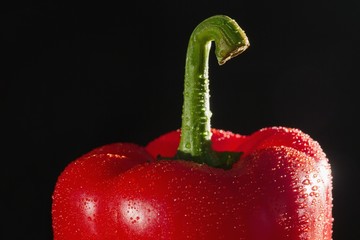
0, 0, 360, 240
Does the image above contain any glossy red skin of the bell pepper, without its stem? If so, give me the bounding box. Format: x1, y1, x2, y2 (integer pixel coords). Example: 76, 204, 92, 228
52, 127, 333, 240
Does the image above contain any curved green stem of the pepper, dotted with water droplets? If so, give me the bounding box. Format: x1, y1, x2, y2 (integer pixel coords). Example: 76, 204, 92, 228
177, 15, 249, 167
